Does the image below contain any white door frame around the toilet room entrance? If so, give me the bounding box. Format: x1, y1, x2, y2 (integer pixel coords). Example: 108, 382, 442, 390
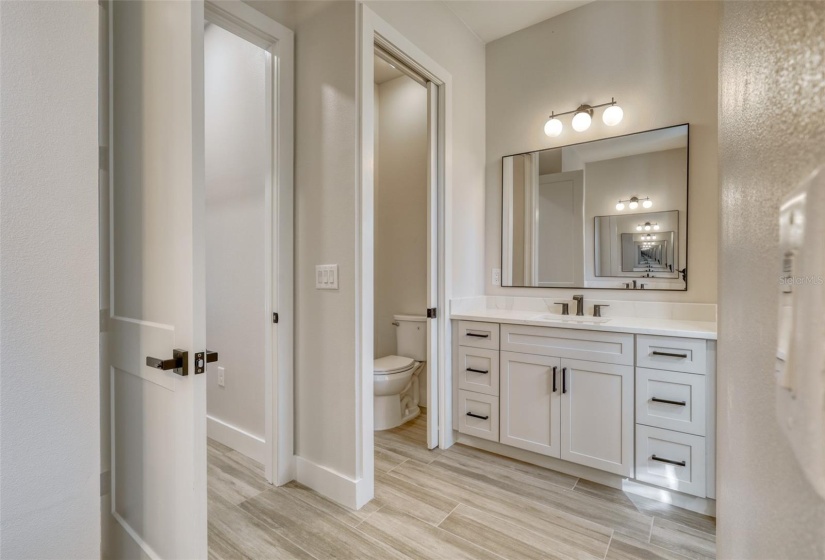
355, 3, 453, 508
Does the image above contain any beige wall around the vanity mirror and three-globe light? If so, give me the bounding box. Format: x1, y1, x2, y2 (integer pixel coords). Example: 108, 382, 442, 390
485, 1, 719, 303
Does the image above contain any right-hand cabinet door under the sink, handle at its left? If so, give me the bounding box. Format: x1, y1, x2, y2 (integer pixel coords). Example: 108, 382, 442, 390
561, 359, 634, 476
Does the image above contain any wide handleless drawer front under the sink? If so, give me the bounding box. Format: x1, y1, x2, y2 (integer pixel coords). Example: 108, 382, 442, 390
501, 325, 633, 366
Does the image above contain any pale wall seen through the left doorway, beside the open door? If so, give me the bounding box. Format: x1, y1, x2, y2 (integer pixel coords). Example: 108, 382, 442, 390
204, 25, 269, 447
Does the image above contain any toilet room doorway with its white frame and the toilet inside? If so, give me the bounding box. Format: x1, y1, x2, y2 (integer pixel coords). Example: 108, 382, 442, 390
353, 5, 454, 508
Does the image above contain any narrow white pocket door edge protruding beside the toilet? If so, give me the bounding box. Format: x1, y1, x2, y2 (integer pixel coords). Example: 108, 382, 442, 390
427, 82, 439, 449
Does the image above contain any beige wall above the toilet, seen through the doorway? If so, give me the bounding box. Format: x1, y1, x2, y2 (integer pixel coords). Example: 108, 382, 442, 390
375, 76, 427, 358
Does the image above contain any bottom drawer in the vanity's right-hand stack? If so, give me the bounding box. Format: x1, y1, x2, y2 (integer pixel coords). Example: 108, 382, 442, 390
636, 425, 706, 498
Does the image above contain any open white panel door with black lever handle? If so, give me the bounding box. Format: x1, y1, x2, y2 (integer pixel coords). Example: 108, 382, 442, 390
109, 0, 207, 559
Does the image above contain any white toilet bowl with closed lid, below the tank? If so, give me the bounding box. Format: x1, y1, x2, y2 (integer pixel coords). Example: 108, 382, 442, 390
373, 356, 424, 430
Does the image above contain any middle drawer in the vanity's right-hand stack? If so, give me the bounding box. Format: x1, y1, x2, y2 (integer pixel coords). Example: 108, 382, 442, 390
636, 368, 707, 436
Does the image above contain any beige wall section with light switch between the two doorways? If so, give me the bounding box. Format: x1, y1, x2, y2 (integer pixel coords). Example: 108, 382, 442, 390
295, 1, 358, 478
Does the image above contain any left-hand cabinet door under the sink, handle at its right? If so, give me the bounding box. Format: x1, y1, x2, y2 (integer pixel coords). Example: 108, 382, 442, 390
499, 352, 561, 457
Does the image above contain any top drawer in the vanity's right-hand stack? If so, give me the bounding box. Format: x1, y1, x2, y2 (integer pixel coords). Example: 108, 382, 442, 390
636, 334, 707, 374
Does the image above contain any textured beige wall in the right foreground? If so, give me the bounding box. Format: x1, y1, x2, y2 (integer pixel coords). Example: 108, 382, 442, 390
717, 2, 825, 559
